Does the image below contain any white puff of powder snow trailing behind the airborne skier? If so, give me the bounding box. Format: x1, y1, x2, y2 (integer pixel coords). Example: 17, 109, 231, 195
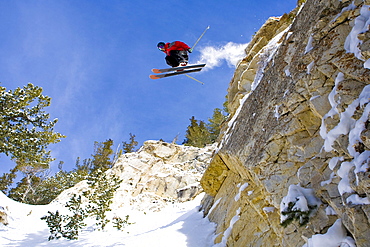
198, 42, 248, 69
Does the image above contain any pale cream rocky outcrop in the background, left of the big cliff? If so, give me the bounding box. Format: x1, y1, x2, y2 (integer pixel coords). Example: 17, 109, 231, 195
55, 141, 215, 211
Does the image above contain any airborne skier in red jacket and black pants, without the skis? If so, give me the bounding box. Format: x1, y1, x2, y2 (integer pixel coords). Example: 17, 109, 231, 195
157, 41, 193, 67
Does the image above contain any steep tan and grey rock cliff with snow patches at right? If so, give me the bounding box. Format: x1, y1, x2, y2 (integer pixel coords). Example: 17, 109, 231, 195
201, 0, 370, 246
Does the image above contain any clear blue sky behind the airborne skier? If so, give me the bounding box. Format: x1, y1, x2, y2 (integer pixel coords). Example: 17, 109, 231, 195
0, 0, 296, 172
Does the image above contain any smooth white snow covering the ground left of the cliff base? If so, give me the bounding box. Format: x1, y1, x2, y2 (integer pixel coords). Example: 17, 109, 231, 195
0, 193, 220, 247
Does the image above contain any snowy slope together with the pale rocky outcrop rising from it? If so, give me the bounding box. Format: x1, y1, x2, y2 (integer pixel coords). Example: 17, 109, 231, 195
0, 141, 215, 247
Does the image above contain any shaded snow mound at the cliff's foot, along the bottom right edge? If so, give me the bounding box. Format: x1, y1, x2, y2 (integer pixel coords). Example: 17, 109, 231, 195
302, 219, 356, 247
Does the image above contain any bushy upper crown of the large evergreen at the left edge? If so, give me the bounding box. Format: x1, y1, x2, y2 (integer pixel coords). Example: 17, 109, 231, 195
0, 83, 64, 166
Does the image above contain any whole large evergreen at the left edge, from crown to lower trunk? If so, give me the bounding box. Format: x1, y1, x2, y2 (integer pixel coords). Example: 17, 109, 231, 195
0, 83, 65, 202
